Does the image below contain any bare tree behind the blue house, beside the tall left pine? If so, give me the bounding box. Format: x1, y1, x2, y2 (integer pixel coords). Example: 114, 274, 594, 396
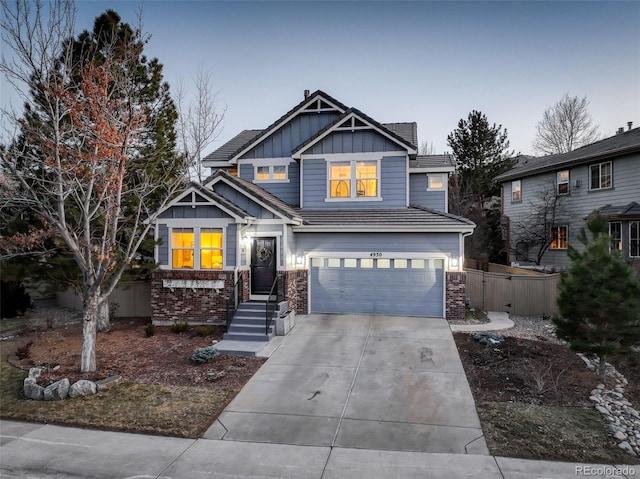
176, 68, 227, 183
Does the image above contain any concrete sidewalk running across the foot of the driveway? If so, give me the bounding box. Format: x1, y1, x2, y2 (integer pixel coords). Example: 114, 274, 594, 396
0, 420, 640, 479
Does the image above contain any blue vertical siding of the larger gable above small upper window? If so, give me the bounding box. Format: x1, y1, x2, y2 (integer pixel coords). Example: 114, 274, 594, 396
242, 112, 339, 159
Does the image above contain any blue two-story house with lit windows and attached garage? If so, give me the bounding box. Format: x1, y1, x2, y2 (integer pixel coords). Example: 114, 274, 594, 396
152, 91, 475, 330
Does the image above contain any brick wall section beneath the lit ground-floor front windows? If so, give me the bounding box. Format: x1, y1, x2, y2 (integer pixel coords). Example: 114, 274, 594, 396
151, 270, 235, 321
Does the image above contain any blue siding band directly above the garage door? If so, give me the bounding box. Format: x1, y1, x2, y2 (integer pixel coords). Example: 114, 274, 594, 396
295, 231, 460, 257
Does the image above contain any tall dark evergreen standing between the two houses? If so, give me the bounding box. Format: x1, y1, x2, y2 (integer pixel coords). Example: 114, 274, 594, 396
447, 110, 514, 262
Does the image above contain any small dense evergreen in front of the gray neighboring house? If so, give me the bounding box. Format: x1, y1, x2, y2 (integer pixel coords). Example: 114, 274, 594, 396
554, 215, 640, 383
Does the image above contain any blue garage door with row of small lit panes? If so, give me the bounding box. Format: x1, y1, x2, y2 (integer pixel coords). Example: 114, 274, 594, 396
311, 257, 444, 318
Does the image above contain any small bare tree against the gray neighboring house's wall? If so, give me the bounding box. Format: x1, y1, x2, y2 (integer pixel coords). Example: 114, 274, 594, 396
511, 180, 566, 265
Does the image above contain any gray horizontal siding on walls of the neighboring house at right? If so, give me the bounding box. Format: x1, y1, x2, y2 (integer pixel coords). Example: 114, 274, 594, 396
503, 155, 640, 267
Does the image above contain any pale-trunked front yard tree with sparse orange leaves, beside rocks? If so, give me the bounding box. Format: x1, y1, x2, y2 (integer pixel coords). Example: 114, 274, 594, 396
0, 0, 183, 372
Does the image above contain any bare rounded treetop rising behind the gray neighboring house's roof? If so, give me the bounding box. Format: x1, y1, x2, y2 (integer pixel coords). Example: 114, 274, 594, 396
533, 93, 600, 155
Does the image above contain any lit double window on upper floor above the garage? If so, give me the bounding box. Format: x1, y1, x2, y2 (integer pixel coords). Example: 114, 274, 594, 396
328, 160, 380, 199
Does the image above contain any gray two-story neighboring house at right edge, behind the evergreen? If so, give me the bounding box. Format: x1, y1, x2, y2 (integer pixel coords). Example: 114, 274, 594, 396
497, 126, 640, 268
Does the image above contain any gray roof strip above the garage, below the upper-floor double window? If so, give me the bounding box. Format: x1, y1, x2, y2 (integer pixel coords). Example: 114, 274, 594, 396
296, 206, 475, 232
